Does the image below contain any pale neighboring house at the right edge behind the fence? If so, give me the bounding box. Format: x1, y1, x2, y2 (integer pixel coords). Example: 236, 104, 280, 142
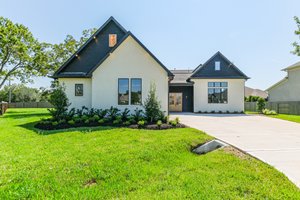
266, 62, 300, 102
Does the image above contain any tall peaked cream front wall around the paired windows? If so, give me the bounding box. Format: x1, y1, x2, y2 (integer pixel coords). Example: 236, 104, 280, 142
92, 36, 168, 112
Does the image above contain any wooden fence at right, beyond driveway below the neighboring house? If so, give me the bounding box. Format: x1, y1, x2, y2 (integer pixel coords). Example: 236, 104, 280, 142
245, 101, 300, 115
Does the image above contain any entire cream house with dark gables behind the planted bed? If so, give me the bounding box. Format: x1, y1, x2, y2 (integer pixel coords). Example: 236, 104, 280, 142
53, 17, 248, 112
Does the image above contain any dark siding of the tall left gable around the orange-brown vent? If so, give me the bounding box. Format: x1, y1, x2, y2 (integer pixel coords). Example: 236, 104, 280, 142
53, 17, 126, 78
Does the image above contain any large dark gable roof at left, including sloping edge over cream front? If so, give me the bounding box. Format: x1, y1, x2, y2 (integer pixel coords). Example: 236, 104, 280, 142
52, 17, 173, 78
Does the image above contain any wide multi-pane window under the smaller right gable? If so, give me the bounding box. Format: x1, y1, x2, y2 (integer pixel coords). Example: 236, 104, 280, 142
208, 82, 228, 103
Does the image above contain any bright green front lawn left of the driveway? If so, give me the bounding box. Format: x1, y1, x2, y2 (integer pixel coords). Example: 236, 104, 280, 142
0, 109, 300, 199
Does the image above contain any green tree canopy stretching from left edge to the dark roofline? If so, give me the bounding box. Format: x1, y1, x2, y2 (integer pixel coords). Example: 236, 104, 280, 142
0, 16, 96, 89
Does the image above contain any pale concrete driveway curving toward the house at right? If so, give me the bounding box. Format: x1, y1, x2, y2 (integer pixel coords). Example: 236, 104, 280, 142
171, 113, 300, 187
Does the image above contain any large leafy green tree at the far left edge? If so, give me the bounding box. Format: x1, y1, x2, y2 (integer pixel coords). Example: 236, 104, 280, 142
0, 17, 50, 89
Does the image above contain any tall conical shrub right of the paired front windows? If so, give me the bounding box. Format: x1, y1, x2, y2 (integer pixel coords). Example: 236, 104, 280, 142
144, 84, 163, 123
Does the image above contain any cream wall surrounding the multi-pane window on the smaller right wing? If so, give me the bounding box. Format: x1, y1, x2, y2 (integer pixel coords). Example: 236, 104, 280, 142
191, 79, 245, 112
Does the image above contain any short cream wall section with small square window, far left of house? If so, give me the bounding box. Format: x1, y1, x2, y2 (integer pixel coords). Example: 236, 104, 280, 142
58, 78, 92, 109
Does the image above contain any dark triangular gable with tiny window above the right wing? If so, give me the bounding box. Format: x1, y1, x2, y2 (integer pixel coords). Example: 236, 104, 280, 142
190, 52, 249, 79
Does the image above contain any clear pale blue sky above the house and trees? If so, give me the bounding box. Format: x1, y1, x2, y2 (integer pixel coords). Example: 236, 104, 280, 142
0, 0, 300, 89
